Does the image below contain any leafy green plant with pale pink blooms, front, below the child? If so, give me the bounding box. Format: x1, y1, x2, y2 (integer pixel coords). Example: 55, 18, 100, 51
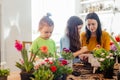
32, 58, 54, 80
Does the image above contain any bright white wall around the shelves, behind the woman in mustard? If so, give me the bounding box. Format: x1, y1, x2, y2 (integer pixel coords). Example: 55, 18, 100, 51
75, 0, 120, 35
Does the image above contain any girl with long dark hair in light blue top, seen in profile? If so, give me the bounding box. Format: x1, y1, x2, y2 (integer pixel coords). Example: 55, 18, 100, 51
60, 16, 88, 61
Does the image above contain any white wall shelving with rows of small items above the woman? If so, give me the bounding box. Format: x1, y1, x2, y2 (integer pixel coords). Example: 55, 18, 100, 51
79, 0, 114, 15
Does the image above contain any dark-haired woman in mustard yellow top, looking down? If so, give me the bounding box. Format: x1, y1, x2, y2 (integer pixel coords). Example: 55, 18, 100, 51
80, 12, 110, 51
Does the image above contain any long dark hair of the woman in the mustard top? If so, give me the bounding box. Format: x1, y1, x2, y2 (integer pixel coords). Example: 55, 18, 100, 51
85, 12, 102, 45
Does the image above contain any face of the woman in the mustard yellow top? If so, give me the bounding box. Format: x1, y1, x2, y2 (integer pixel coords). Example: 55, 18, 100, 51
86, 19, 98, 33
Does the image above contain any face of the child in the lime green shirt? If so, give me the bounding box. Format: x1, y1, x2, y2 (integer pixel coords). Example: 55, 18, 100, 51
40, 26, 54, 39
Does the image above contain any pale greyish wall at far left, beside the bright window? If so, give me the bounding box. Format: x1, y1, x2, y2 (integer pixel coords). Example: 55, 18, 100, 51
1, 0, 32, 71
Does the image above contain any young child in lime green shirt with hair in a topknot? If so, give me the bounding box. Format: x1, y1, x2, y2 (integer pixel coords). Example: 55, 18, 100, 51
31, 14, 56, 55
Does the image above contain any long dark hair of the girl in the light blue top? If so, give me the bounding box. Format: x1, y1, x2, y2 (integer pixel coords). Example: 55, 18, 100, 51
66, 16, 83, 52
